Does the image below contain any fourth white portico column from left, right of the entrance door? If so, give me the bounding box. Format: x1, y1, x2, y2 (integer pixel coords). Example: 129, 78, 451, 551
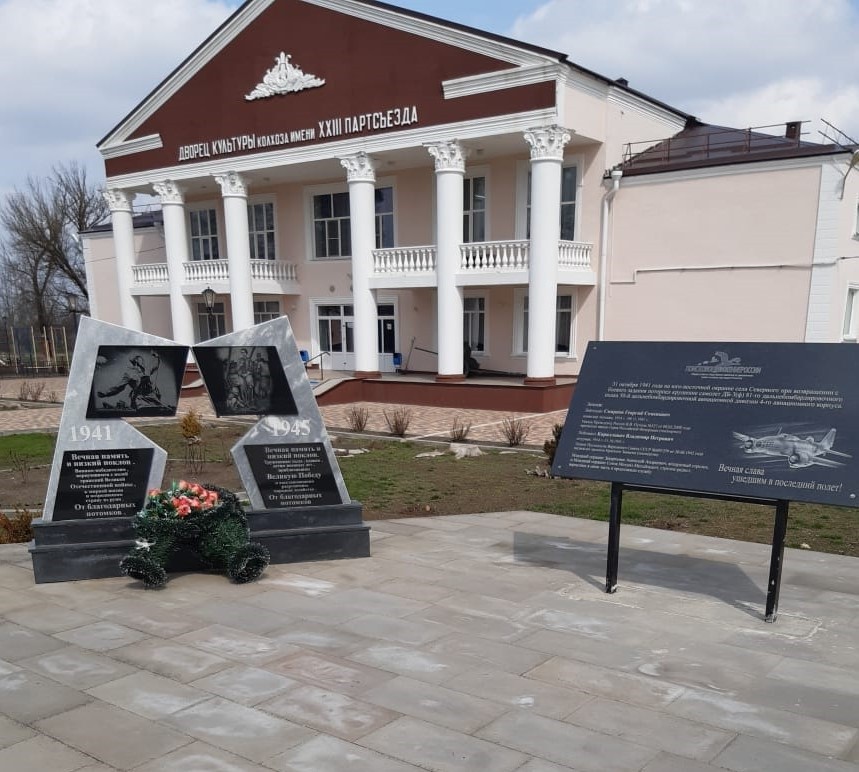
340, 153, 379, 378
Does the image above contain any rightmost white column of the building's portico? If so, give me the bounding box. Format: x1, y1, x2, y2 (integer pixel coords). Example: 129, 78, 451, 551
525, 126, 570, 383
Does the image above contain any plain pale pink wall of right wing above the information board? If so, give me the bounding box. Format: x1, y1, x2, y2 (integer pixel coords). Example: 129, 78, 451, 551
606, 166, 820, 341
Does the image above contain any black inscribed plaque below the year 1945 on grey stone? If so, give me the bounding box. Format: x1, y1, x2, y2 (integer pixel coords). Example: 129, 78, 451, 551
243, 442, 344, 508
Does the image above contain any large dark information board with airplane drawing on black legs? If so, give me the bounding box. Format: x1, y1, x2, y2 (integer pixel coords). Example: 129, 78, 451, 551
552, 342, 859, 507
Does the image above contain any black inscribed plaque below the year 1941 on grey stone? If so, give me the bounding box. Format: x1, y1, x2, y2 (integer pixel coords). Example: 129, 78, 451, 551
53, 448, 153, 520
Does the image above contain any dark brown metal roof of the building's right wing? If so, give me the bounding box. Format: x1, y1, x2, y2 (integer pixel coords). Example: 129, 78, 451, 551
620, 118, 851, 177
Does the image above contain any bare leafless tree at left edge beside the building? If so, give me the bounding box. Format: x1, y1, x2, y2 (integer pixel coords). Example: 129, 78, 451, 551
0, 163, 108, 312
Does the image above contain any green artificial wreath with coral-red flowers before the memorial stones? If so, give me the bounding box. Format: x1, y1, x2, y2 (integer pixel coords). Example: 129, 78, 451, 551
119, 480, 269, 588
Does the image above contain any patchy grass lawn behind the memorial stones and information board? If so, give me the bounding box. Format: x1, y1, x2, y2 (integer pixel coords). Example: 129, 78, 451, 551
0, 423, 859, 556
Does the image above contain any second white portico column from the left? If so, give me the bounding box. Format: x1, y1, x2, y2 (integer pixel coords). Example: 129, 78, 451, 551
152, 180, 194, 346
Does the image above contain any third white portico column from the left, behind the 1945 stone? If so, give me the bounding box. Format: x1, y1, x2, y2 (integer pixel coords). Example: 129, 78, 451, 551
215, 172, 254, 332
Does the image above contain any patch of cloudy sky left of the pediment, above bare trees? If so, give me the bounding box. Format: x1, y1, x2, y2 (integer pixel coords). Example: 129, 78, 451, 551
0, 0, 238, 194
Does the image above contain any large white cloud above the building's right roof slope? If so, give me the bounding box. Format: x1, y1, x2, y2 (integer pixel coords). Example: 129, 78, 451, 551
512, 0, 859, 139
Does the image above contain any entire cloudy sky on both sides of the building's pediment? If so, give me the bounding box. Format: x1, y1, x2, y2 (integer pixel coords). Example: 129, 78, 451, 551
0, 0, 859, 195
